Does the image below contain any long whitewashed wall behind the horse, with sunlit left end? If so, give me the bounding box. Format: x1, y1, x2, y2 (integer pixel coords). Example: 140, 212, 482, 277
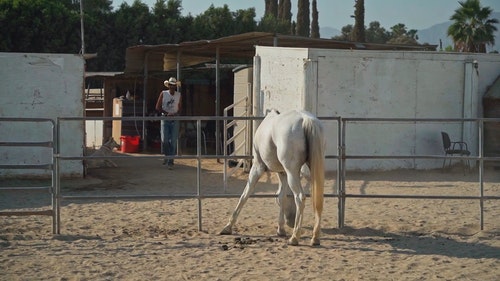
254, 46, 500, 170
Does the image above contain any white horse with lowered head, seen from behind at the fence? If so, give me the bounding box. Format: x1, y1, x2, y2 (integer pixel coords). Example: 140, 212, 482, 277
220, 110, 325, 246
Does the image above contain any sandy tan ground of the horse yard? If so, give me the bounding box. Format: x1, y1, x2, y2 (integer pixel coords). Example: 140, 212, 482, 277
0, 155, 500, 280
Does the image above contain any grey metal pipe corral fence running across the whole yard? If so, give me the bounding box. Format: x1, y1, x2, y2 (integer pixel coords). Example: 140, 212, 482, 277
0, 116, 500, 234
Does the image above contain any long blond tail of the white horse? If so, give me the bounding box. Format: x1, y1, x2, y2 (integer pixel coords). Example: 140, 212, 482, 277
303, 116, 325, 219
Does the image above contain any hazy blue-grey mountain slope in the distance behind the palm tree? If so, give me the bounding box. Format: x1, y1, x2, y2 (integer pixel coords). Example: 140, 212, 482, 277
417, 12, 500, 52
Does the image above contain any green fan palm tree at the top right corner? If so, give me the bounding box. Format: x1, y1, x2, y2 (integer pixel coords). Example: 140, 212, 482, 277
448, 0, 498, 53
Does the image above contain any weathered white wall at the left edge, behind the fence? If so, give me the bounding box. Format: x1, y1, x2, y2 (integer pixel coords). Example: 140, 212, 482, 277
0, 53, 84, 176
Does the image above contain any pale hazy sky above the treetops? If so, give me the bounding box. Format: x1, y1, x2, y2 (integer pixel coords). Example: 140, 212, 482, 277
113, 0, 500, 30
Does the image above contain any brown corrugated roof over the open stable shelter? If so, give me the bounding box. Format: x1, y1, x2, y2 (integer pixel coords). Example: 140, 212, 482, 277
125, 32, 437, 73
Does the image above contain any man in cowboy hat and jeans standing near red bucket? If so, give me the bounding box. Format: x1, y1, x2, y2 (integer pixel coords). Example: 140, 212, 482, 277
156, 77, 182, 170
